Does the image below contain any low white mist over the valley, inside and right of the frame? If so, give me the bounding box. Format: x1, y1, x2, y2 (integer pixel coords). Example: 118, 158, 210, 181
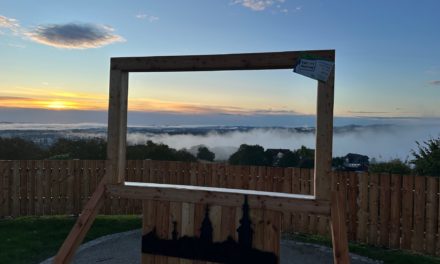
128, 125, 440, 160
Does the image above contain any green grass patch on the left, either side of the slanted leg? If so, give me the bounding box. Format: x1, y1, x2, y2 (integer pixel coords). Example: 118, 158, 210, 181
0, 216, 142, 263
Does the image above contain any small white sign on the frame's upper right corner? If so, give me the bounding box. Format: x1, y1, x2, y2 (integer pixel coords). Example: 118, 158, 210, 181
293, 59, 335, 82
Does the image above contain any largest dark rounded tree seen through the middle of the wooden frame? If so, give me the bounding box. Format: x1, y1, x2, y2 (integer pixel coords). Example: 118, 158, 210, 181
229, 144, 268, 166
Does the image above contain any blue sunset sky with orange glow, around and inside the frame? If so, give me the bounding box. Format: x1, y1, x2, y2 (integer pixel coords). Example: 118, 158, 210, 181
0, 0, 440, 125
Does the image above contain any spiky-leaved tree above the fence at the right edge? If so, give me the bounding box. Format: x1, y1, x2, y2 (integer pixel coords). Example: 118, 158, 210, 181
411, 137, 440, 176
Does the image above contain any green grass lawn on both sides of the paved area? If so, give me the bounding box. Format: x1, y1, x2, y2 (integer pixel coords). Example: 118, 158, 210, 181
0, 216, 440, 264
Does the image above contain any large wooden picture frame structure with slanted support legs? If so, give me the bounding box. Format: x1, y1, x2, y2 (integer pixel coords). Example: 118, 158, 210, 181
55, 50, 349, 263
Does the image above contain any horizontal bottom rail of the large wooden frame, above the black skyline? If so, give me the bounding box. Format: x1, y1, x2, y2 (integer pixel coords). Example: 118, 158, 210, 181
107, 182, 330, 215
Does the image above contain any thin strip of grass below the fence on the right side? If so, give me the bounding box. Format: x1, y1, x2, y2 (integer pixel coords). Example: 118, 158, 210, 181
283, 234, 440, 264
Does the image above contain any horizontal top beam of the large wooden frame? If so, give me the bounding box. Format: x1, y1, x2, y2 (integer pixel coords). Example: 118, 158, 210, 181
111, 50, 334, 72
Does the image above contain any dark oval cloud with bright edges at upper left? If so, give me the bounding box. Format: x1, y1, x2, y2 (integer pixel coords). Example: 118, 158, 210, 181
26, 23, 124, 49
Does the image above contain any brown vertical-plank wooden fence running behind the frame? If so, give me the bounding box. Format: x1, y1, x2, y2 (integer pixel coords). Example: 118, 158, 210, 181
0, 160, 440, 255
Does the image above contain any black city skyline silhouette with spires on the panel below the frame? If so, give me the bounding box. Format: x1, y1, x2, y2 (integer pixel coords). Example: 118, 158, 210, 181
142, 196, 278, 264
